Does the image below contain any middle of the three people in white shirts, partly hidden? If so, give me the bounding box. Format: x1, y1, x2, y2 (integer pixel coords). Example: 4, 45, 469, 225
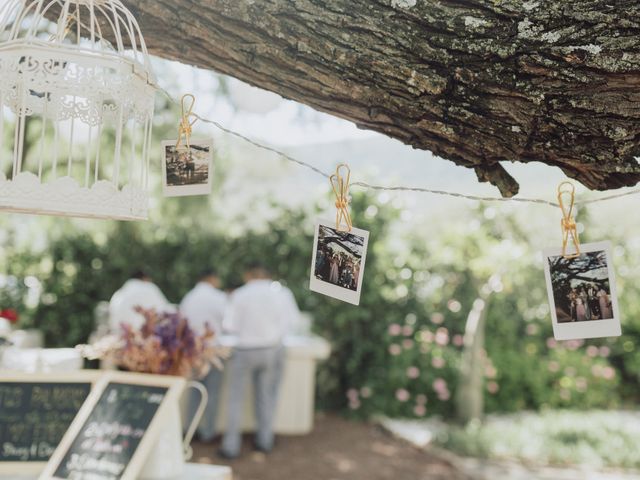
180, 270, 227, 442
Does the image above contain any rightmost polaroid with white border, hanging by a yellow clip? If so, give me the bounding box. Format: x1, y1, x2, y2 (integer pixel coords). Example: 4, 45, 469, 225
543, 242, 622, 340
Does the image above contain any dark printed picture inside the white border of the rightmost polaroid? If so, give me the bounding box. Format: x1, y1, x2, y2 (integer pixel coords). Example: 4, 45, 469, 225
548, 250, 613, 323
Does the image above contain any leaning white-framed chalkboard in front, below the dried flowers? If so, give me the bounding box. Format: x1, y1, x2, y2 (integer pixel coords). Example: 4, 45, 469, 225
39, 372, 186, 480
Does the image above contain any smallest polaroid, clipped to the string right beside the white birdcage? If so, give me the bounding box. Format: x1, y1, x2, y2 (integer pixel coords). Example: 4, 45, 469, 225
162, 140, 213, 197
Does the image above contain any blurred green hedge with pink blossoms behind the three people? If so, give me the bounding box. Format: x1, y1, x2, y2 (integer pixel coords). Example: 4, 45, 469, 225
1, 194, 640, 417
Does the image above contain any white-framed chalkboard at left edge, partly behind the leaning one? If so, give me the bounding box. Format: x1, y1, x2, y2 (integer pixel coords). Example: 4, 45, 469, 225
0, 370, 102, 475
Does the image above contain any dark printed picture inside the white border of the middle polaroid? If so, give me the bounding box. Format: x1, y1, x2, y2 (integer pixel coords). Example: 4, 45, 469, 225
315, 225, 365, 292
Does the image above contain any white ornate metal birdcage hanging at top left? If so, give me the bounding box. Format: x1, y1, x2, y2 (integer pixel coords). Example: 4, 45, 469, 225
0, 0, 155, 220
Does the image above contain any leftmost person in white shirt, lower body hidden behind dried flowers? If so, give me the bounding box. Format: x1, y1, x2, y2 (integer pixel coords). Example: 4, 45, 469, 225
109, 270, 174, 334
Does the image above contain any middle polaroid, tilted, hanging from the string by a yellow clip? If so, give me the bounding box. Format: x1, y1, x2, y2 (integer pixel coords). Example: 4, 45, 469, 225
310, 221, 369, 305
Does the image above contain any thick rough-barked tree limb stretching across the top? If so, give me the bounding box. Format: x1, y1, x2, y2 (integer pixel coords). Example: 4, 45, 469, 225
124, 0, 640, 196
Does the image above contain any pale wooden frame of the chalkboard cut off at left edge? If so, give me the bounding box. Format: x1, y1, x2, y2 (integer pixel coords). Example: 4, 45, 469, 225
0, 370, 103, 475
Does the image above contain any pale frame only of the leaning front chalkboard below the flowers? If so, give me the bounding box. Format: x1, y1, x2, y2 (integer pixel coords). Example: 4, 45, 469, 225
38, 372, 186, 480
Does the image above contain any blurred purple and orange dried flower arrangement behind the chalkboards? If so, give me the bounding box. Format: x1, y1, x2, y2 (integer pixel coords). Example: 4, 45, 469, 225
79, 308, 228, 378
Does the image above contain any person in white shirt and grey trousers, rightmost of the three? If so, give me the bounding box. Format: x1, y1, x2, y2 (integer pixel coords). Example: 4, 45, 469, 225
219, 264, 300, 458
